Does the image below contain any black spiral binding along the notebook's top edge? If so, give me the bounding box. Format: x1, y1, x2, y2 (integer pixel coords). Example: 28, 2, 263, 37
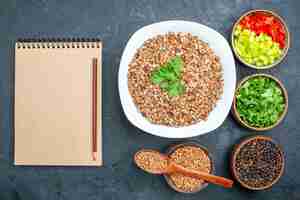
16, 38, 101, 49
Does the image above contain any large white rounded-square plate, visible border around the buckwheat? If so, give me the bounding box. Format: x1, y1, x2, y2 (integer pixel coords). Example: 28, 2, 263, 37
119, 21, 236, 138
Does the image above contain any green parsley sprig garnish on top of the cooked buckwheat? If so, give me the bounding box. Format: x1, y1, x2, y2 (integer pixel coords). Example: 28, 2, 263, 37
150, 56, 185, 97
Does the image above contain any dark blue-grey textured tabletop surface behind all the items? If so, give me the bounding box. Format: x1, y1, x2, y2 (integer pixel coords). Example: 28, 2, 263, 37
0, 0, 300, 200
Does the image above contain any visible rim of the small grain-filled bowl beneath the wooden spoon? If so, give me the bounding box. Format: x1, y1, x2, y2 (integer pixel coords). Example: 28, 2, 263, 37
164, 142, 214, 194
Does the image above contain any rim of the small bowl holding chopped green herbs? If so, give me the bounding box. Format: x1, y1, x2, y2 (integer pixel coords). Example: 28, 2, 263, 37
231, 74, 288, 131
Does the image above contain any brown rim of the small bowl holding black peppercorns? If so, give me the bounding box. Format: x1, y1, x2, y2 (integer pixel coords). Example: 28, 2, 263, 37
230, 135, 285, 190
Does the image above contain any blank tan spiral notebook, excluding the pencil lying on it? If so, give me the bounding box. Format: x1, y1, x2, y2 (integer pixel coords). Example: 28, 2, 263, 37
14, 41, 102, 166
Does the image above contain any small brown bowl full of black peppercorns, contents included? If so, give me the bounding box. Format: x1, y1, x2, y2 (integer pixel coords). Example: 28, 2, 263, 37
232, 136, 284, 190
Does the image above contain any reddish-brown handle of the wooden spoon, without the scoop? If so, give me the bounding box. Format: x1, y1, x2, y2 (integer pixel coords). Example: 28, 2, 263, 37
171, 163, 233, 188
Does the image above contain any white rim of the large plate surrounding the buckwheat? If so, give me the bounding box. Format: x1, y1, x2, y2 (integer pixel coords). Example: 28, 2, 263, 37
118, 20, 236, 138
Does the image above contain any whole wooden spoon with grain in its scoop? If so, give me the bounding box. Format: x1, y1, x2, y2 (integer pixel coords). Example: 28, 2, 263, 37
134, 149, 233, 188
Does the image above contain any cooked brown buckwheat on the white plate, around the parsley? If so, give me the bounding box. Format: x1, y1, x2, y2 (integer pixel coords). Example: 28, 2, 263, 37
128, 33, 223, 126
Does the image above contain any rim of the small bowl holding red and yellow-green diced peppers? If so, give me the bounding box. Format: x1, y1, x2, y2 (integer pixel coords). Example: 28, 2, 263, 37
231, 10, 290, 69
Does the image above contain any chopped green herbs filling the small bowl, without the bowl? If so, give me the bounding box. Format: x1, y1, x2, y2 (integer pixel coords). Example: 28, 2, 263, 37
236, 77, 285, 127
